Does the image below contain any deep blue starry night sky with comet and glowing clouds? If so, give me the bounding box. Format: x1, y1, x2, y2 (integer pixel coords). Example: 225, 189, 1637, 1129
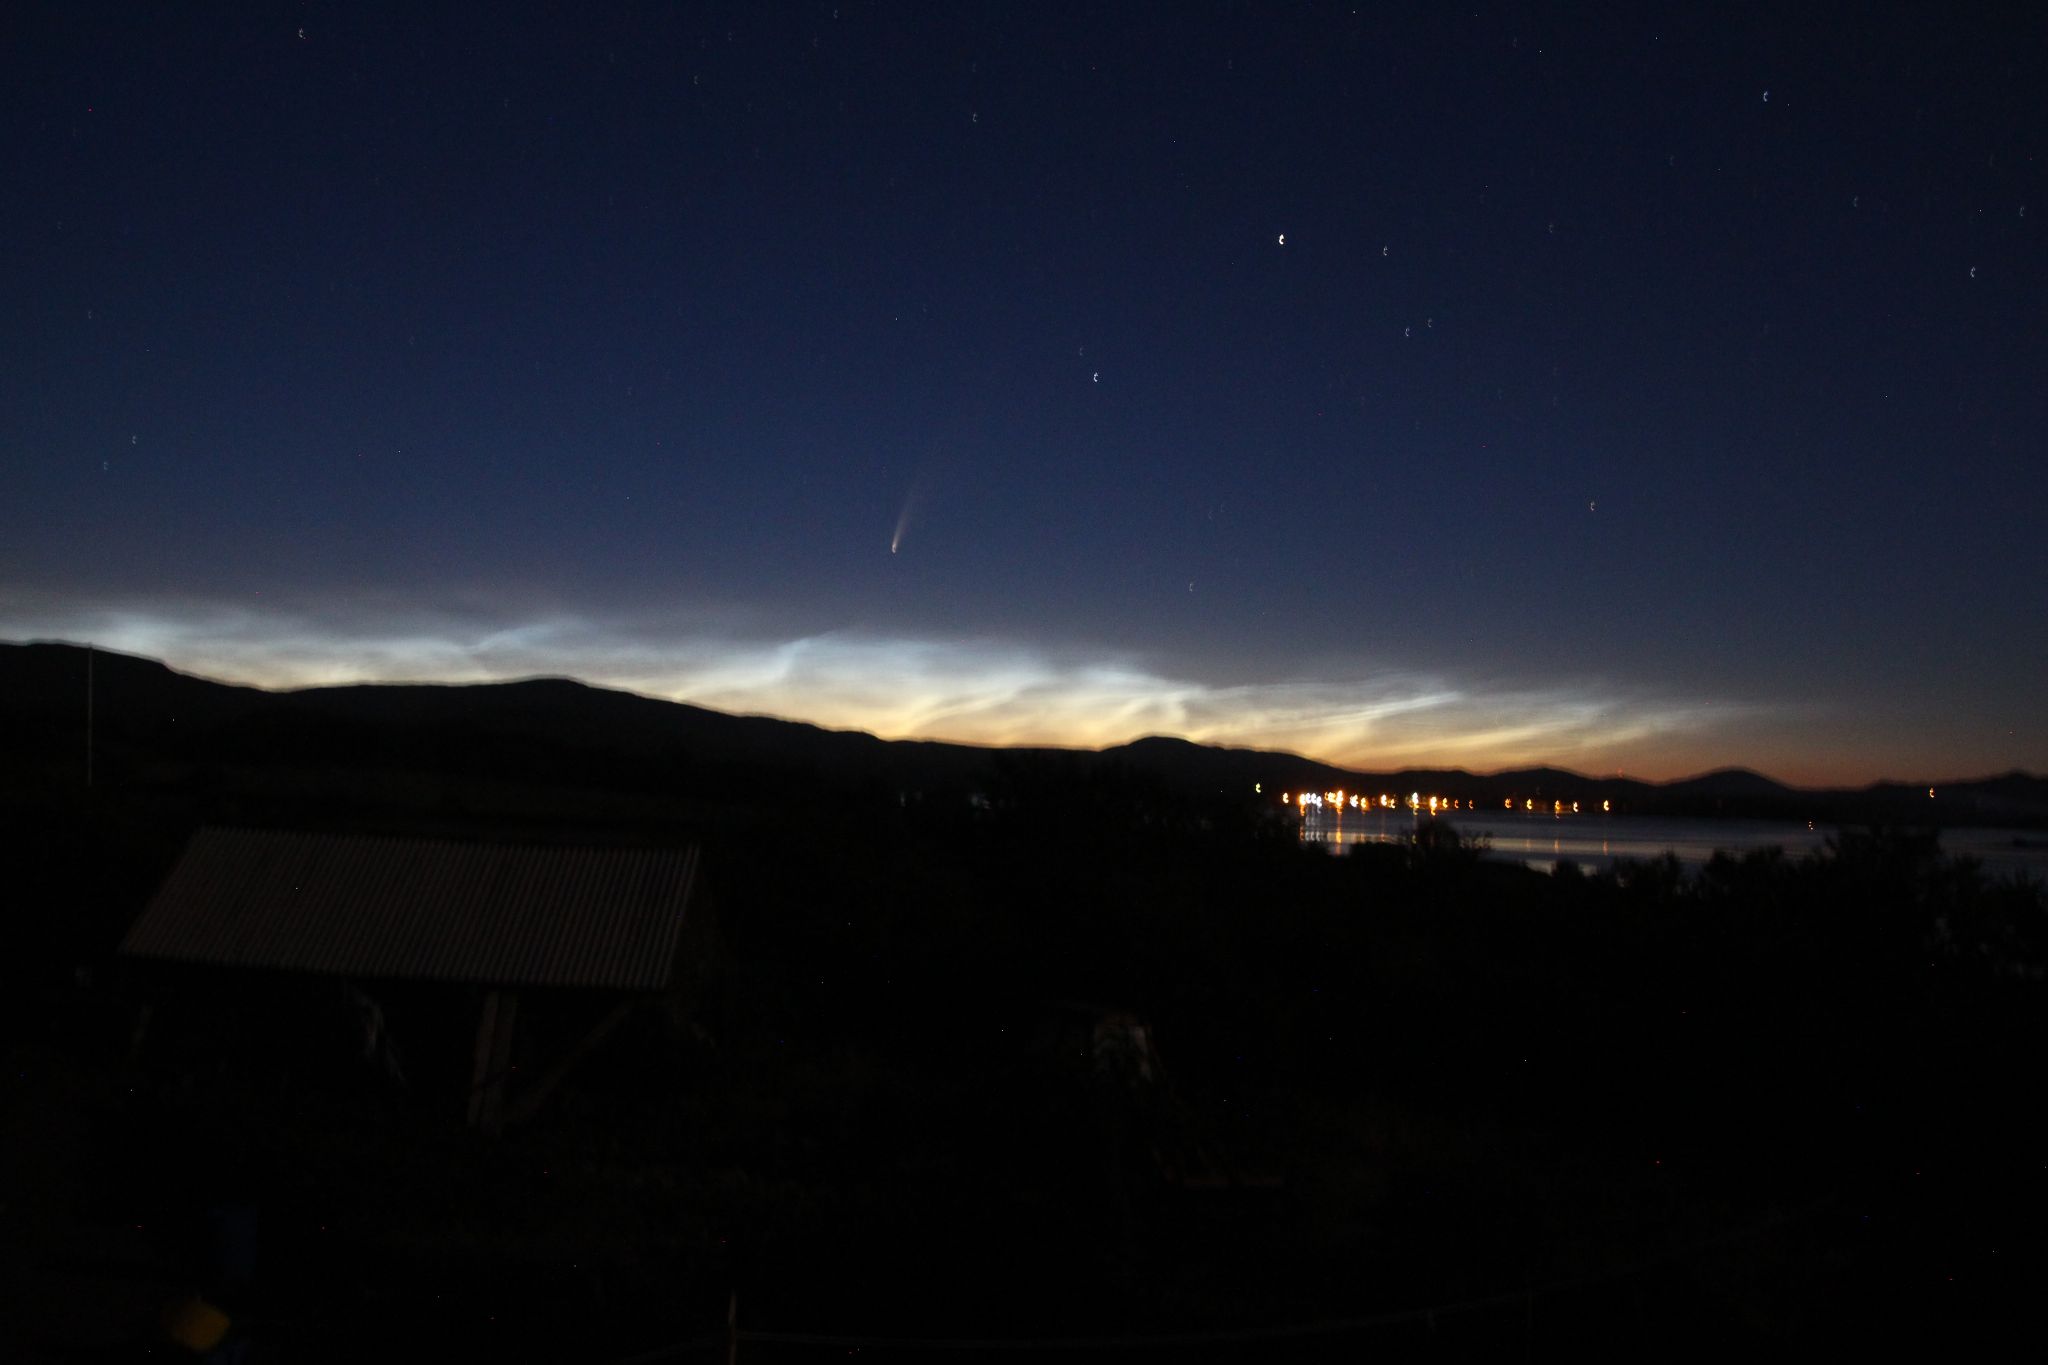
0, 2, 2048, 784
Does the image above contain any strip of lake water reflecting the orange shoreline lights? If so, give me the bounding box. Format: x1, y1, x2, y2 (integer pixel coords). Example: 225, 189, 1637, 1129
1300, 808, 2048, 876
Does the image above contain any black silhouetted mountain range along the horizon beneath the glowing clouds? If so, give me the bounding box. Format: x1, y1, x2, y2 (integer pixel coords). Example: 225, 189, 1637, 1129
0, 643, 2048, 825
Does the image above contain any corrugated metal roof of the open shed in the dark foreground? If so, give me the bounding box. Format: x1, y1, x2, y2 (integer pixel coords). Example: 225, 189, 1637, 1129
121, 829, 696, 990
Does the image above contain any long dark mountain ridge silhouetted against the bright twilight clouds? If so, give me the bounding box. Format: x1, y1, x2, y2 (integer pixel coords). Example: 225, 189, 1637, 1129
0, 641, 2048, 823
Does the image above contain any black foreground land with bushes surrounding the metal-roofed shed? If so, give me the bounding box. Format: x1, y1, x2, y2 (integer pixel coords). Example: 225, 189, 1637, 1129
0, 769, 2048, 1361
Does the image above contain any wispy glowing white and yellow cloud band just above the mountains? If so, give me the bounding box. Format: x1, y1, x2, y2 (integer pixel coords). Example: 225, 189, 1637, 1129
0, 593, 1739, 772
